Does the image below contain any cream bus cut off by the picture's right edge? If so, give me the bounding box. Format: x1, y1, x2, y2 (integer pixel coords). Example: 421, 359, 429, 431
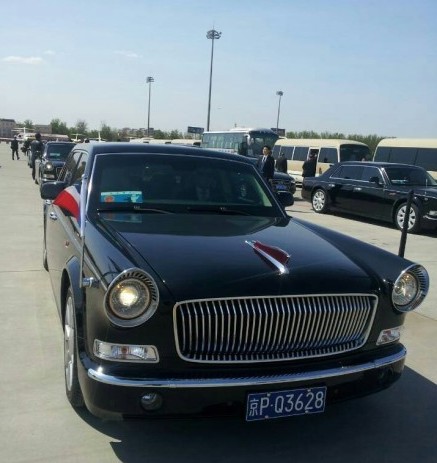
373, 138, 437, 179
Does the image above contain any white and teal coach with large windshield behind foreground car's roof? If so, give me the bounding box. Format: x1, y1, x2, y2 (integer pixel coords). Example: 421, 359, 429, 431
200, 127, 279, 157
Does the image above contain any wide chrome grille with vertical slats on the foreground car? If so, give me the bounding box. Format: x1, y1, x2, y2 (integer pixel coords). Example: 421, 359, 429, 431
174, 294, 378, 363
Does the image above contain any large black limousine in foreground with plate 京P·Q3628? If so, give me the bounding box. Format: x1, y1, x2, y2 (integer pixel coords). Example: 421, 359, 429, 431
41, 143, 429, 421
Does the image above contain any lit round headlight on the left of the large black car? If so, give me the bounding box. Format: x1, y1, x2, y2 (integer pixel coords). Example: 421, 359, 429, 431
104, 269, 159, 328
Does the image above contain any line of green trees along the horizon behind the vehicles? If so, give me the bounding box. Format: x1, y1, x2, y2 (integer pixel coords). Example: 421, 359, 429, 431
17, 118, 387, 153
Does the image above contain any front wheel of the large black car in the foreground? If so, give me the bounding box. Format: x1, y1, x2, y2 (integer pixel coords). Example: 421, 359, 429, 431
64, 288, 84, 408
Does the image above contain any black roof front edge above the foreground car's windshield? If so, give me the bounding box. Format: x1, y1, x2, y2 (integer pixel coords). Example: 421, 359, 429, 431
75, 142, 253, 164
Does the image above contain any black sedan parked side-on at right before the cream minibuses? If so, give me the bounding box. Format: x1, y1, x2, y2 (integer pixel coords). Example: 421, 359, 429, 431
302, 162, 437, 233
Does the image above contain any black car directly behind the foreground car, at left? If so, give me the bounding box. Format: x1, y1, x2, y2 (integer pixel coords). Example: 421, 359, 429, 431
35, 141, 76, 185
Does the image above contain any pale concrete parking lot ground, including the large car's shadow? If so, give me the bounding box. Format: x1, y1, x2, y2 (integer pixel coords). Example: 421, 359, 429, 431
0, 143, 437, 463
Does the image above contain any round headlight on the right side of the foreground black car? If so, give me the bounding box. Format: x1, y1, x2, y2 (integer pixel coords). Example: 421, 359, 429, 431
391, 265, 429, 312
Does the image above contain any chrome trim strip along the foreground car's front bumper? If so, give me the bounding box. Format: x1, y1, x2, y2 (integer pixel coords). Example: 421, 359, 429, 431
88, 347, 407, 389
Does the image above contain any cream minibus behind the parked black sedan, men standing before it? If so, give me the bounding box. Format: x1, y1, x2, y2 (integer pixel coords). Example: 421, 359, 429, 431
273, 138, 372, 183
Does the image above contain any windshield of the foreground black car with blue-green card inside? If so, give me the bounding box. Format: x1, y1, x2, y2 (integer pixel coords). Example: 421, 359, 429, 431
88, 154, 280, 217
